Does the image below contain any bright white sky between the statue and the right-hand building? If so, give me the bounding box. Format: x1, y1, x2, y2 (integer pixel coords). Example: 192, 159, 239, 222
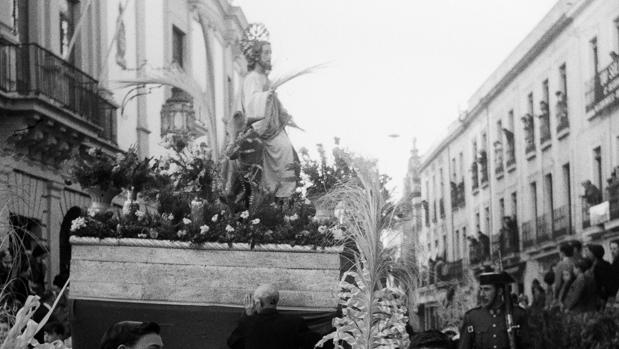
233, 0, 556, 196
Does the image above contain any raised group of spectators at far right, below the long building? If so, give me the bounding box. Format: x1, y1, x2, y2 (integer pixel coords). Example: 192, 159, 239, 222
519, 240, 619, 313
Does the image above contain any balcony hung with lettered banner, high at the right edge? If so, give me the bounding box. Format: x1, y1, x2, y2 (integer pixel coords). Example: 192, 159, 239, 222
585, 58, 619, 114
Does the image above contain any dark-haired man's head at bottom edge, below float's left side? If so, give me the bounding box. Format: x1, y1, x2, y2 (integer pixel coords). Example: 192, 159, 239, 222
100, 321, 163, 349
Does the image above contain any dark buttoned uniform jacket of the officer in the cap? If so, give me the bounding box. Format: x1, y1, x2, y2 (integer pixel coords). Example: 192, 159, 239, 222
460, 304, 531, 349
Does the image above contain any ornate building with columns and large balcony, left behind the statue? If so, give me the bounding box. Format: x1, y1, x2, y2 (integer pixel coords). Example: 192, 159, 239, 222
0, 0, 247, 283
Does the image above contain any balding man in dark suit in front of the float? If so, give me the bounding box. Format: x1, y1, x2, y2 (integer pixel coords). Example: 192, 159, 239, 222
228, 284, 316, 349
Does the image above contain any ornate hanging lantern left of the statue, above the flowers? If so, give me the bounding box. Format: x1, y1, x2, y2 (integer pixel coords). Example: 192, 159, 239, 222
161, 87, 196, 137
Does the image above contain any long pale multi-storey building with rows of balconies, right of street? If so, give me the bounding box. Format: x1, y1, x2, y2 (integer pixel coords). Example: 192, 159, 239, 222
412, 0, 619, 327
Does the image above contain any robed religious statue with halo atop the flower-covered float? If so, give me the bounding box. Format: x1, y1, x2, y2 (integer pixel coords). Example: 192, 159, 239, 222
227, 24, 299, 198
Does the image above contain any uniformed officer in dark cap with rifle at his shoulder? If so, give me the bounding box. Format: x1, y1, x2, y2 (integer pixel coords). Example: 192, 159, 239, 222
460, 272, 531, 349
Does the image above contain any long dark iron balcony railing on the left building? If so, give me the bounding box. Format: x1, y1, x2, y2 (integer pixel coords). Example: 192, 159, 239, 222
0, 42, 116, 142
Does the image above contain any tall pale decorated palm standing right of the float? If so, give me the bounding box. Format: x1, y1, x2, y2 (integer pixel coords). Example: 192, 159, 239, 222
319, 159, 413, 349
